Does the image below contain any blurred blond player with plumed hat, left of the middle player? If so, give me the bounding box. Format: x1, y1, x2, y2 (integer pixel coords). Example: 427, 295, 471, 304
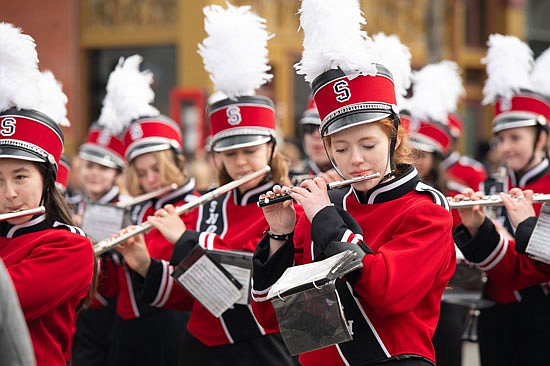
98, 55, 195, 365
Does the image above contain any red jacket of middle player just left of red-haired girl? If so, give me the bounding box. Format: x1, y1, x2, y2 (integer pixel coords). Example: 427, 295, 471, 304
137, 182, 302, 346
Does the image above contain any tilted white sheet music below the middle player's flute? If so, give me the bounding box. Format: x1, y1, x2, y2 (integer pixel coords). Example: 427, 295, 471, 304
177, 255, 244, 318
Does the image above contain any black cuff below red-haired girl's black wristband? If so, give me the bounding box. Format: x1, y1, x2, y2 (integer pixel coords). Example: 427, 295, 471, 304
252, 235, 294, 291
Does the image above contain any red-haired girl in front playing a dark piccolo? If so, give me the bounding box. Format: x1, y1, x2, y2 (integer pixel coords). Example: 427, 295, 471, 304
253, 0, 455, 366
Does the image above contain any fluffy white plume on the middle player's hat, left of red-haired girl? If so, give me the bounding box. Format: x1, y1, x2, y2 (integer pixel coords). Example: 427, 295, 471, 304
198, 3, 273, 99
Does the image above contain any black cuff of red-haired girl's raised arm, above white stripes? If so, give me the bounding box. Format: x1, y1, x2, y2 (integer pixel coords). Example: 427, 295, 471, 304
311, 206, 348, 251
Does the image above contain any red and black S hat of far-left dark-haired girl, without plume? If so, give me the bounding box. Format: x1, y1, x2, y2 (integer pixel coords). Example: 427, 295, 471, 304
0, 109, 63, 169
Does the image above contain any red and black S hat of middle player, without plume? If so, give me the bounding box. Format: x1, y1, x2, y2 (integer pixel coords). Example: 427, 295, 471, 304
208, 96, 275, 151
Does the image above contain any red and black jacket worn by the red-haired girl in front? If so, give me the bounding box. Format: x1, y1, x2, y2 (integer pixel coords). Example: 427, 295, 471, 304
252, 167, 456, 366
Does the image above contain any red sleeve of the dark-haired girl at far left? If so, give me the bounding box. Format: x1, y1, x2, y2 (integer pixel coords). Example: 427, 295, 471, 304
8, 230, 95, 321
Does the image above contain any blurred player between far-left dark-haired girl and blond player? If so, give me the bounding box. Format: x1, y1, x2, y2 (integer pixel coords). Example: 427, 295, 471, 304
72, 123, 126, 366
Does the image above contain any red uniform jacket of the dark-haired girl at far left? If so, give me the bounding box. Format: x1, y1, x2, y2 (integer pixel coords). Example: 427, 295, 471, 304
0, 214, 94, 366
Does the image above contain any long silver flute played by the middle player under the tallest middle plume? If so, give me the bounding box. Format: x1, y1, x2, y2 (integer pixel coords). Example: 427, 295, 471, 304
94, 165, 271, 255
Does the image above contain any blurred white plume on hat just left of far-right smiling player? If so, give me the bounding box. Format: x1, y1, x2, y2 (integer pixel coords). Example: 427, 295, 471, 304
407, 61, 465, 124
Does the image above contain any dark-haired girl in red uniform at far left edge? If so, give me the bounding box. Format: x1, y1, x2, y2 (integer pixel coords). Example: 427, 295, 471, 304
0, 23, 95, 365
